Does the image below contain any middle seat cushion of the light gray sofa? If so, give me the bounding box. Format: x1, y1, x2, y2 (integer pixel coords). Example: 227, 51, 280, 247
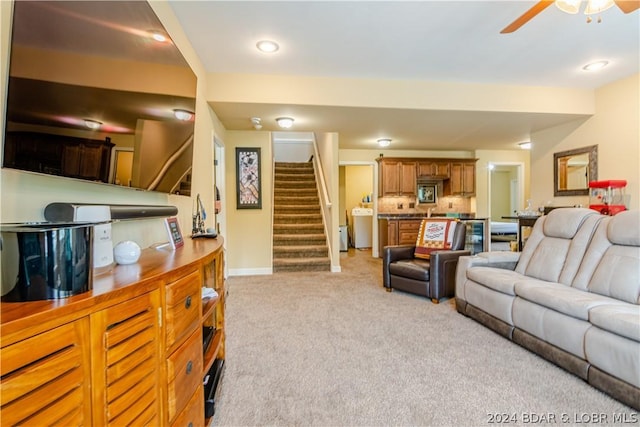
515, 279, 624, 320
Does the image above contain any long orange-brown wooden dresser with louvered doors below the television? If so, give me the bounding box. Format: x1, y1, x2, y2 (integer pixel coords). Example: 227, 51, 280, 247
0, 237, 226, 426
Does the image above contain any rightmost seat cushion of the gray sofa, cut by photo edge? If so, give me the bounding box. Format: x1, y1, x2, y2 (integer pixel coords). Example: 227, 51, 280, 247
589, 304, 640, 342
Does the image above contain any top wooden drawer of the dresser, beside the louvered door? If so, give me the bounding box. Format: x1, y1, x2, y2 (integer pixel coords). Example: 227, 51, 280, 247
165, 271, 202, 352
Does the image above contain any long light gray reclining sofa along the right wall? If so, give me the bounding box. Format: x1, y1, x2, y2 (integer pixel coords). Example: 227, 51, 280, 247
456, 208, 640, 410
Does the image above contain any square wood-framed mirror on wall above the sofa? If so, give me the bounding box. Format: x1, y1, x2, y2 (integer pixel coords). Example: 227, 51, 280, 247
553, 145, 598, 196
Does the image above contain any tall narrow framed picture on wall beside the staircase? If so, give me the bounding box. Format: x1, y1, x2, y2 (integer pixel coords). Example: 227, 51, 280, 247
236, 148, 262, 209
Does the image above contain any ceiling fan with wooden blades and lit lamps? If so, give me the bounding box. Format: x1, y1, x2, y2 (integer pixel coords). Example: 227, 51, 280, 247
500, 0, 640, 34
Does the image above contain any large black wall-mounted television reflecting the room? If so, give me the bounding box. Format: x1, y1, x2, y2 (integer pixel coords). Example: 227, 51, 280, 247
2, 0, 197, 195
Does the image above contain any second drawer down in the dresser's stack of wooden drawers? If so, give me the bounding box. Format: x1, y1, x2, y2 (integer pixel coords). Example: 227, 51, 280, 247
167, 328, 204, 421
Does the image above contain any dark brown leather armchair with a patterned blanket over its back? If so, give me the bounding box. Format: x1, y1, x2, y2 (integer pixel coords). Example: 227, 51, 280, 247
382, 222, 471, 304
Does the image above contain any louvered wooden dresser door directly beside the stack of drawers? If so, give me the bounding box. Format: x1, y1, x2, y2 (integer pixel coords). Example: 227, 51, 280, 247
91, 291, 160, 426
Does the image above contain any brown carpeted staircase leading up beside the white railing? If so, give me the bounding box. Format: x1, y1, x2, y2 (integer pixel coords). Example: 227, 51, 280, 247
273, 162, 331, 273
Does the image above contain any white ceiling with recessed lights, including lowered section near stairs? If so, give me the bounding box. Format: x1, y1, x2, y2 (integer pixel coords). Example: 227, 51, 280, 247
170, 0, 640, 149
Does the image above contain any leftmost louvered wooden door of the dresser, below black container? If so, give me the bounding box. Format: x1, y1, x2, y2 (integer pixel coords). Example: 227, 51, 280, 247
0, 318, 91, 426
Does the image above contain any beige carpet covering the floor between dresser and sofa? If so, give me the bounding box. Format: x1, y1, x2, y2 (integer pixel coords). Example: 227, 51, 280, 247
213, 250, 638, 426
